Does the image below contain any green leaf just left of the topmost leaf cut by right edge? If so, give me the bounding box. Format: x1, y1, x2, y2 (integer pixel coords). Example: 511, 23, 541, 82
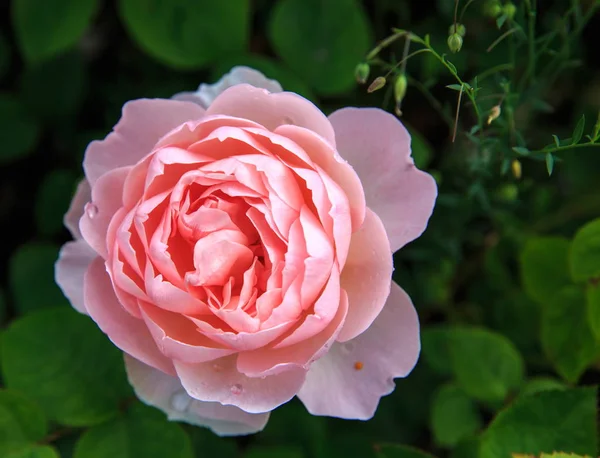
520, 237, 571, 305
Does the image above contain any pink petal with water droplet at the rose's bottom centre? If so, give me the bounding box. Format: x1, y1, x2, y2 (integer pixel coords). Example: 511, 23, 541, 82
174, 356, 306, 413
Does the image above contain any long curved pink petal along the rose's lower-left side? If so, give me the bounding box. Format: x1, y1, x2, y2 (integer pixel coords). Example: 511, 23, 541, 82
83, 257, 175, 374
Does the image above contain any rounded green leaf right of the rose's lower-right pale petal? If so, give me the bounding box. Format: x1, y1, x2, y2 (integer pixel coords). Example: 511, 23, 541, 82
450, 328, 523, 402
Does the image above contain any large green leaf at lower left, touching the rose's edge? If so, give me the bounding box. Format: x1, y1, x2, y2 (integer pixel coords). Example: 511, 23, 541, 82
2, 307, 132, 426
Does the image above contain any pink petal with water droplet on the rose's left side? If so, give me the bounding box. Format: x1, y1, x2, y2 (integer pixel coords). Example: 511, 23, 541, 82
79, 167, 130, 259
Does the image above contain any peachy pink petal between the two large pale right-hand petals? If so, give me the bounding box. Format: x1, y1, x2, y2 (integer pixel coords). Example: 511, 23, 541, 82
338, 208, 394, 342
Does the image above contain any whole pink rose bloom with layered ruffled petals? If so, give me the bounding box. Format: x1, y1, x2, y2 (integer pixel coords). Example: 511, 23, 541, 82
56, 67, 437, 435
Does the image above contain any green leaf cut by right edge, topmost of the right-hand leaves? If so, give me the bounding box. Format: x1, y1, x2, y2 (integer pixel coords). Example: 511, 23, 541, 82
569, 218, 600, 281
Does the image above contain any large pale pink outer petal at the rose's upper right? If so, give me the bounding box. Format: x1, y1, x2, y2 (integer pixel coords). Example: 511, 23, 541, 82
329, 108, 437, 251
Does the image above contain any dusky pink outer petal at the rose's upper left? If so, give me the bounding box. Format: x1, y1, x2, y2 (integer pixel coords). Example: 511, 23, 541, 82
83, 99, 204, 187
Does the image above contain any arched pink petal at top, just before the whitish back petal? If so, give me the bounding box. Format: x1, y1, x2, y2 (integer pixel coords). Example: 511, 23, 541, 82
206, 84, 335, 146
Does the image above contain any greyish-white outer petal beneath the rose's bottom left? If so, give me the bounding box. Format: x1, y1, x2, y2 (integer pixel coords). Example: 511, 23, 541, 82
125, 354, 269, 436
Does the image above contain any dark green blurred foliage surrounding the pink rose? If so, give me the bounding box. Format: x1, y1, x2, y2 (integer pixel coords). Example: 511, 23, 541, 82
0, 0, 600, 458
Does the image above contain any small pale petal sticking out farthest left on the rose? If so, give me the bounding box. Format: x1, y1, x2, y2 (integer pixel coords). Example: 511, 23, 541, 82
54, 240, 98, 314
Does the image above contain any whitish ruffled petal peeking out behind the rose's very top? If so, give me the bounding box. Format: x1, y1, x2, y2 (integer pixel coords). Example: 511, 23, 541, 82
173, 66, 283, 108
